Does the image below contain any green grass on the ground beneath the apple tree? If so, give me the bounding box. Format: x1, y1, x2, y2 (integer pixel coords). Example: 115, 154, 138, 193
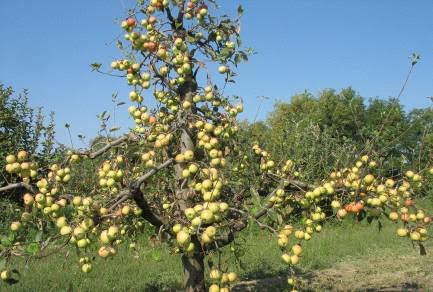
4, 200, 433, 291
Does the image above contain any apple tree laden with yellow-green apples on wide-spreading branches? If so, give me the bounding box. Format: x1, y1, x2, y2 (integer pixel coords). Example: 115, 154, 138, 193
0, 0, 433, 291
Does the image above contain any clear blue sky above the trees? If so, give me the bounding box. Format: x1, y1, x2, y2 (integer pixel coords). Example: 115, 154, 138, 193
0, 0, 433, 146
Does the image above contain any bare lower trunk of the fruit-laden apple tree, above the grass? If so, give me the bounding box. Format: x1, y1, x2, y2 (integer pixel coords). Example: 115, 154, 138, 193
182, 252, 205, 292
